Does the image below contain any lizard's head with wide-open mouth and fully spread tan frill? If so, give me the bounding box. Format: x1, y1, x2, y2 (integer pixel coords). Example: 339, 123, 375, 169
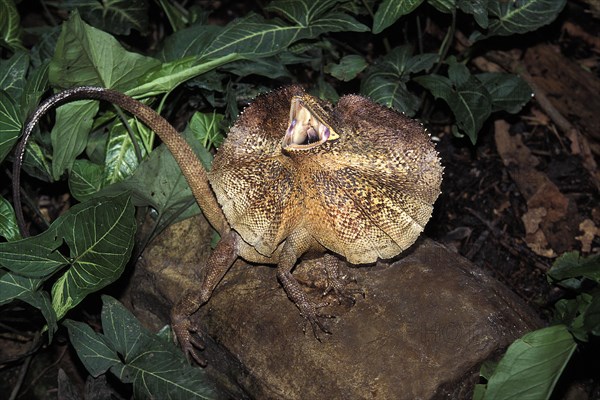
209, 86, 442, 263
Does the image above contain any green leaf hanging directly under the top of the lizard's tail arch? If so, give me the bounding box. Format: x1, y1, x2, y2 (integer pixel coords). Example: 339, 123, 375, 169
50, 100, 99, 180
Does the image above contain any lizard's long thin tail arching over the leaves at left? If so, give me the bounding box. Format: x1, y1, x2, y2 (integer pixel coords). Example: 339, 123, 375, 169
13, 86, 230, 236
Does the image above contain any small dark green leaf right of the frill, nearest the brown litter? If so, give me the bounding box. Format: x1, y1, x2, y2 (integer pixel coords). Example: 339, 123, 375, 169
475, 72, 533, 114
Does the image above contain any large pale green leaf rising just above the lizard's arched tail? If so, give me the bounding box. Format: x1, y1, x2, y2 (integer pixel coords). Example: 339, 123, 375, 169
49, 11, 160, 91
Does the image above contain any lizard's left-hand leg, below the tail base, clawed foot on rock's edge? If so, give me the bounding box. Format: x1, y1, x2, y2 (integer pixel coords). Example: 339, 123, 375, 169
171, 231, 240, 366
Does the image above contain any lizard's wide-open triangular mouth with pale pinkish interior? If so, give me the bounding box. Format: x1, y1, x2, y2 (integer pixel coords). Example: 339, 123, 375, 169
283, 96, 339, 150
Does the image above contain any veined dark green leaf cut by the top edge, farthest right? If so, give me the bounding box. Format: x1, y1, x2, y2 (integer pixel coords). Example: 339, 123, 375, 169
471, 0, 566, 41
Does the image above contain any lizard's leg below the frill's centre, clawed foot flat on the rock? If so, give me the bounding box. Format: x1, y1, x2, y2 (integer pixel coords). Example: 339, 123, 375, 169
277, 233, 333, 339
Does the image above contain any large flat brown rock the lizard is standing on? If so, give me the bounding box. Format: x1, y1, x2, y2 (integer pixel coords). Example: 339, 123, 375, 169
131, 217, 540, 399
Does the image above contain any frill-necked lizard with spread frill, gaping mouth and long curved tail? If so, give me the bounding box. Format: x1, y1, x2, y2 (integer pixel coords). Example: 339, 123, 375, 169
14, 86, 442, 364
